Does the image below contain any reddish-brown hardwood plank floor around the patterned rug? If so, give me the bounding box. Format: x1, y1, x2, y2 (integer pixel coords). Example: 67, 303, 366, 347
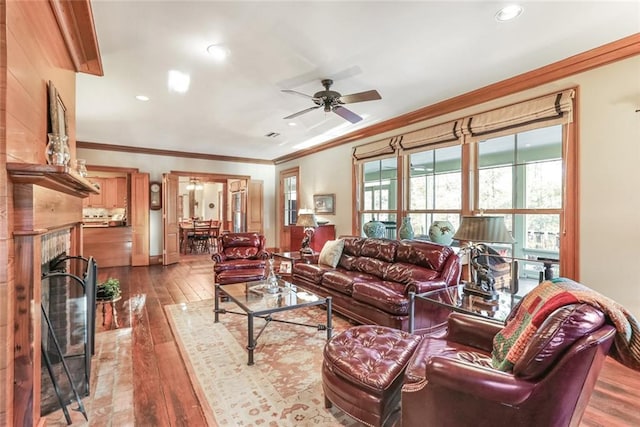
48, 255, 640, 427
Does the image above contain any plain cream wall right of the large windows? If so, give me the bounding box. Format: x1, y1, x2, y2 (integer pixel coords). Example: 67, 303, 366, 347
575, 57, 640, 317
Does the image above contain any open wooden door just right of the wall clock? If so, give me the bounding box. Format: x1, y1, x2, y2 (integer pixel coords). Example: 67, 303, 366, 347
162, 174, 180, 265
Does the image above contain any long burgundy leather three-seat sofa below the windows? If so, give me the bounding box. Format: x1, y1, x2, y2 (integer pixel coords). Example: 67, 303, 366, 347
292, 237, 460, 331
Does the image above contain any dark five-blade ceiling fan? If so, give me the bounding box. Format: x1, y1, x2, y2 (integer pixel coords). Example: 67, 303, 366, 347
282, 79, 382, 123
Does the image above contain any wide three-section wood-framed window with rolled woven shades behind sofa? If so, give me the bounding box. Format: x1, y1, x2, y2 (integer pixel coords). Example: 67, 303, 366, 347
353, 89, 578, 279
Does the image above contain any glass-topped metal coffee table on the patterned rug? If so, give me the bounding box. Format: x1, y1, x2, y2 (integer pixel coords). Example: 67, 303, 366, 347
214, 279, 333, 365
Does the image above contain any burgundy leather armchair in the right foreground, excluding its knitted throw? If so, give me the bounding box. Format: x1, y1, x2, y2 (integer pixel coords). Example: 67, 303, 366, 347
402, 304, 615, 427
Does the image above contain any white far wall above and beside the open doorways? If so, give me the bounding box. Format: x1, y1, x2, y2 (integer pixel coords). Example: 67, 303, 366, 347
77, 150, 276, 256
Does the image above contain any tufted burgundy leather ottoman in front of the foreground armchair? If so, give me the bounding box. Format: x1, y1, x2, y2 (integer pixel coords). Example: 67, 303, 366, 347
322, 325, 421, 426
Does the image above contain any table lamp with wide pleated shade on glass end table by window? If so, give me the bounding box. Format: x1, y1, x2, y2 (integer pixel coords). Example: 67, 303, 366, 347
453, 216, 515, 300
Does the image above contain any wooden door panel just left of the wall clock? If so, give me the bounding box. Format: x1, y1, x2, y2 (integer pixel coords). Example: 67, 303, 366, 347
130, 173, 149, 266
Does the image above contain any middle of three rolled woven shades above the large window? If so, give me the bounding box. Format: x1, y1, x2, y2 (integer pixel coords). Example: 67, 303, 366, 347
399, 120, 462, 154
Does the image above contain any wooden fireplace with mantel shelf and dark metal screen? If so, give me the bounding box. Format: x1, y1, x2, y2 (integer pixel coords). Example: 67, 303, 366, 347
6, 163, 98, 425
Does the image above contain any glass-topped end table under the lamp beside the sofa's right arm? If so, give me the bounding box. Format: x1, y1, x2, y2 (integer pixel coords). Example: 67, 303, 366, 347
409, 284, 521, 332
